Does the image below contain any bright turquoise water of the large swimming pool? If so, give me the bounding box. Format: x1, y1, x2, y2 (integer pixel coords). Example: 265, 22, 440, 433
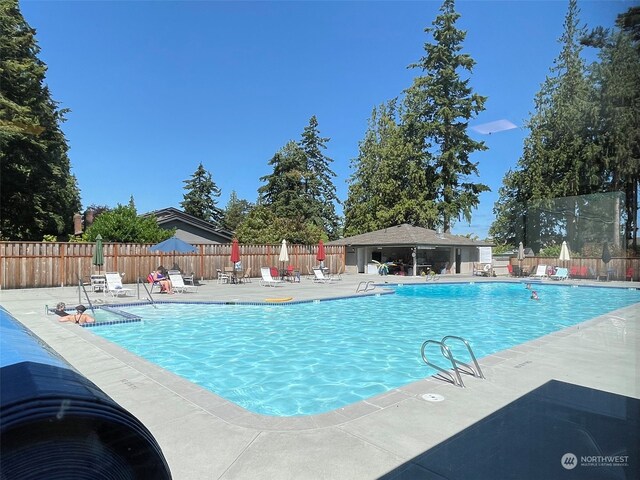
92, 283, 640, 416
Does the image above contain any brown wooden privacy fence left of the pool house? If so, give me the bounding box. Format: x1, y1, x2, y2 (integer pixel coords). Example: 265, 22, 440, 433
0, 242, 345, 289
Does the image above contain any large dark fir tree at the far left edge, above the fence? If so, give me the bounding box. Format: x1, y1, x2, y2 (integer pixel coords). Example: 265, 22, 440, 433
0, 0, 80, 240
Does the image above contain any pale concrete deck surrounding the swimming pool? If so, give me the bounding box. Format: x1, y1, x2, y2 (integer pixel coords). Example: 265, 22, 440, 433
0, 275, 640, 480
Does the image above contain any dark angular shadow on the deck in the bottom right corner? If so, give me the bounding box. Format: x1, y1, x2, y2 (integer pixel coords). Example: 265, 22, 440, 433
382, 380, 640, 480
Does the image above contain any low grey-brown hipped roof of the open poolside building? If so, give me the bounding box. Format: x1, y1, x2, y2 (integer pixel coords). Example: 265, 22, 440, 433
327, 223, 493, 247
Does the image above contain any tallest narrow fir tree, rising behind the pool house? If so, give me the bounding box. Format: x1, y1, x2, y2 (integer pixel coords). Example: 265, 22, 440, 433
403, 0, 489, 231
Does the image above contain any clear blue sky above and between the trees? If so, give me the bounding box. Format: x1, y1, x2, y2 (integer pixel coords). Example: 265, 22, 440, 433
20, 0, 634, 238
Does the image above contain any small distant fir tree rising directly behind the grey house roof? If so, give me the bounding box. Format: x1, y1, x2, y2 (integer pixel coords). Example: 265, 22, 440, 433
180, 163, 223, 226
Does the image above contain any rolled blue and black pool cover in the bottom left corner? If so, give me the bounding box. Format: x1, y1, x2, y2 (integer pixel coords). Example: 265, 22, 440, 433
0, 309, 171, 480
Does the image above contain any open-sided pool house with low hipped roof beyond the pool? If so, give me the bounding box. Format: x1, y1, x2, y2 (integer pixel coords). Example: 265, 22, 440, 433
328, 223, 492, 276
